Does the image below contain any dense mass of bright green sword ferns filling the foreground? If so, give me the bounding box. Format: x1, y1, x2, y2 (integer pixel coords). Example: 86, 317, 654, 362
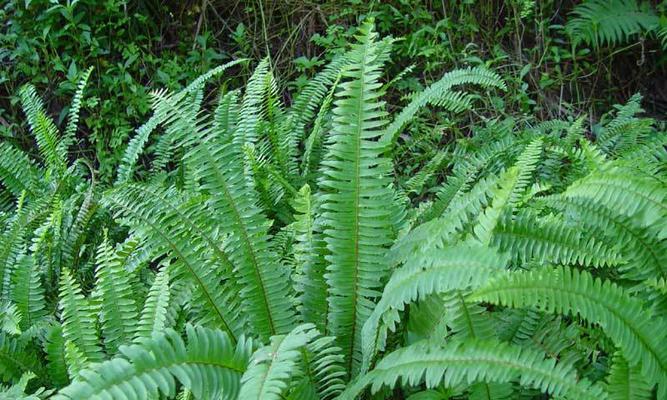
0, 11, 667, 400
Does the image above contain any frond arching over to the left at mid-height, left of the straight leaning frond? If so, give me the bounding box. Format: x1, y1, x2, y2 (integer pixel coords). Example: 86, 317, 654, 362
103, 184, 243, 339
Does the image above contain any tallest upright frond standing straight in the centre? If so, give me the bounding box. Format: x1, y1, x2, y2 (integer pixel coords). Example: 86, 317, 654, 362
320, 18, 400, 371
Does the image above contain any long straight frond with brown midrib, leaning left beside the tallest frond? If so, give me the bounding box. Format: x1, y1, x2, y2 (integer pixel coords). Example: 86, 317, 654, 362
187, 133, 296, 339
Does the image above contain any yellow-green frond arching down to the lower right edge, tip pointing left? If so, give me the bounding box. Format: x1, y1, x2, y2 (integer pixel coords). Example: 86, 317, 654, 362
470, 267, 667, 383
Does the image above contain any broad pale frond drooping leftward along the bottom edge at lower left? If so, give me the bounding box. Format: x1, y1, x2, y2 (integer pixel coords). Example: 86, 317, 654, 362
53, 325, 253, 400
